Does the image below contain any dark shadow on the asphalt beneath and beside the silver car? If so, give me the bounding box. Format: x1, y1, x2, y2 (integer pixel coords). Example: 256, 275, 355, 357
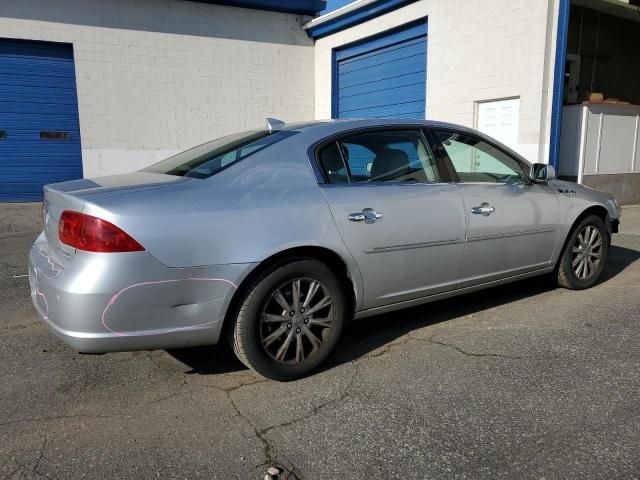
168, 246, 640, 375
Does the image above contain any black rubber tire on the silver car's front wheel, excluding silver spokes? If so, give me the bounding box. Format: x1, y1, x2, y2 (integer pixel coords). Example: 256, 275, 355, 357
556, 215, 610, 290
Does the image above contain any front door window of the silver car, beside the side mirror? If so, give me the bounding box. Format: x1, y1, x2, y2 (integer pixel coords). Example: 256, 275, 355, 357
434, 131, 527, 183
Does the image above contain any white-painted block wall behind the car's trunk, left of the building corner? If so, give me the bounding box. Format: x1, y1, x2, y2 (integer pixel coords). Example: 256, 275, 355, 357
0, 0, 314, 177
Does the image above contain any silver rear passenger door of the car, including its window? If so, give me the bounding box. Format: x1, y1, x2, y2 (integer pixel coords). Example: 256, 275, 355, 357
317, 127, 465, 308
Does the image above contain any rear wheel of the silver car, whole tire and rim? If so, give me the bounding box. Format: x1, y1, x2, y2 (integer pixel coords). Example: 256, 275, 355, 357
232, 258, 347, 380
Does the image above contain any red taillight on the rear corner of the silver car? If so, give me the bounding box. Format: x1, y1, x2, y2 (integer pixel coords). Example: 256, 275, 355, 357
58, 210, 144, 252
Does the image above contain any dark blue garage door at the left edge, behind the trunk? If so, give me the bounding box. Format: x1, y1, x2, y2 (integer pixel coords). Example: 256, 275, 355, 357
0, 39, 82, 202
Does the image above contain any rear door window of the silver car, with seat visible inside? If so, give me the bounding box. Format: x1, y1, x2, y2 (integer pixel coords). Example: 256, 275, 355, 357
319, 130, 440, 183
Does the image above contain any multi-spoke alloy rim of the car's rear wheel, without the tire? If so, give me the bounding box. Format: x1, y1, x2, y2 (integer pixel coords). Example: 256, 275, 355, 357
260, 278, 334, 364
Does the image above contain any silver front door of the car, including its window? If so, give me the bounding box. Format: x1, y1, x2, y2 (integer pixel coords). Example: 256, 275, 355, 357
431, 128, 559, 288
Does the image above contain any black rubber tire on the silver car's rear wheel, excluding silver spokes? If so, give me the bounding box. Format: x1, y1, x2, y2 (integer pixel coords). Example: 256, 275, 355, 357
230, 258, 348, 381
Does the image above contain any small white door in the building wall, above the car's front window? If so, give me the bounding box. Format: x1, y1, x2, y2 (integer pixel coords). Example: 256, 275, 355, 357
476, 98, 520, 152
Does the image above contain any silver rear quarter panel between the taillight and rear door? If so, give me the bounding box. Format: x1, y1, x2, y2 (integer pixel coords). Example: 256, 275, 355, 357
77, 133, 361, 306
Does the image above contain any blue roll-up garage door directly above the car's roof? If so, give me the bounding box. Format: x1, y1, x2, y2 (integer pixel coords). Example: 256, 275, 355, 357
333, 22, 427, 119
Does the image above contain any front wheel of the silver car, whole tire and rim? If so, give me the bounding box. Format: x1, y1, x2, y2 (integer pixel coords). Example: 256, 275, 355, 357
557, 215, 609, 290
